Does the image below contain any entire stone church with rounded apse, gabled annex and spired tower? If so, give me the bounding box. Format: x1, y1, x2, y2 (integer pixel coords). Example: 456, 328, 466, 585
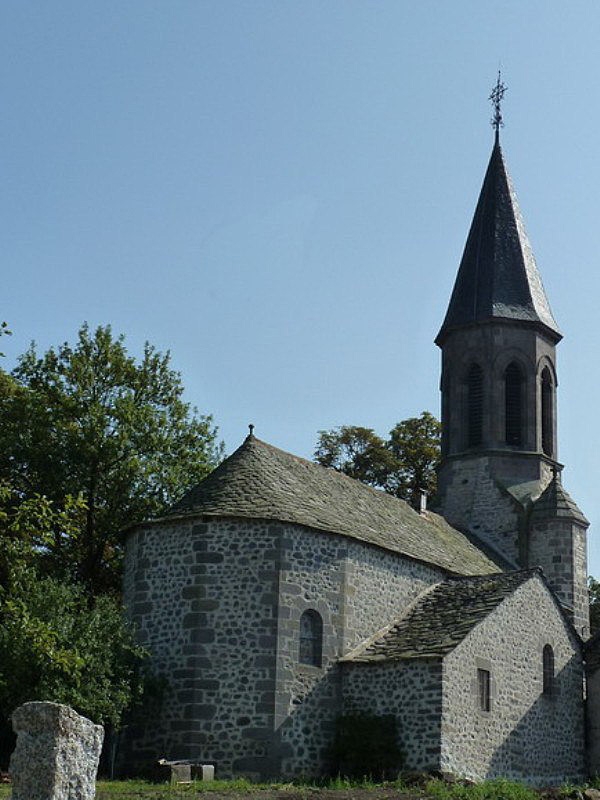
123, 126, 600, 785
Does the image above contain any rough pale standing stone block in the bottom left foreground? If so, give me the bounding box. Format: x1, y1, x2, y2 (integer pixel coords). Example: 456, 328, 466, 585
9, 702, 104, 800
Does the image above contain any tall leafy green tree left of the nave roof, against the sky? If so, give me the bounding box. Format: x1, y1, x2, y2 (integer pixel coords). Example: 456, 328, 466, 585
0, 325, 222, 593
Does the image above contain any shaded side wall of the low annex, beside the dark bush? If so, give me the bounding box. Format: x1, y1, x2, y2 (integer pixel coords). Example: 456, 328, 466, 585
342, 659, 442, 770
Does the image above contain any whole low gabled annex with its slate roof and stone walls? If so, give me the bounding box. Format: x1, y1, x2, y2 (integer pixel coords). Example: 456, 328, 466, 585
342, 570, 584, 785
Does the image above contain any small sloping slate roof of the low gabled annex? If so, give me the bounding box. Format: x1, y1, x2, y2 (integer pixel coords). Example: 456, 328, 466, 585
342, 569, 540, 663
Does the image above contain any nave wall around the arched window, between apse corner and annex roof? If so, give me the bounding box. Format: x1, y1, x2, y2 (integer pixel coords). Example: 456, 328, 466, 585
275, 525, 442, 776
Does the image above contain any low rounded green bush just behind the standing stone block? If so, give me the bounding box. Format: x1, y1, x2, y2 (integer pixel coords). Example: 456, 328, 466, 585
0, 572, 144, 727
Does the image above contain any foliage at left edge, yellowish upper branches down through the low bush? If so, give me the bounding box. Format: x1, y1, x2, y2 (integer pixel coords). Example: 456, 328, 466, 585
0, 484, 144, 736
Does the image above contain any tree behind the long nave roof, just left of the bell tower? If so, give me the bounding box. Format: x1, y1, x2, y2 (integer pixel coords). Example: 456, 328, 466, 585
314, 411, 441, 507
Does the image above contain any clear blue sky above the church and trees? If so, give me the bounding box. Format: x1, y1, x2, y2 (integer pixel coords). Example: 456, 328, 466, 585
0, 0, 600, 576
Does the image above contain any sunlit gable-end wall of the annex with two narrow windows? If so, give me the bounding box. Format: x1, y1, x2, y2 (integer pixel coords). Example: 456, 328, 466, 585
441, 576, 584, 785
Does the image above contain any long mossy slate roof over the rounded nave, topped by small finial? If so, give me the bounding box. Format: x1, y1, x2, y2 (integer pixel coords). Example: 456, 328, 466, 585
170, 436, 502, 575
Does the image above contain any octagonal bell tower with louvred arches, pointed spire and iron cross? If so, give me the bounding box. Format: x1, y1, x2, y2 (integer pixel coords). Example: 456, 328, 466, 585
435, 77, 589, 636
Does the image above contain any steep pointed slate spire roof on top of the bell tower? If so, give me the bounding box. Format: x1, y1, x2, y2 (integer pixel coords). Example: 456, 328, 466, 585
436, 142, 562, 345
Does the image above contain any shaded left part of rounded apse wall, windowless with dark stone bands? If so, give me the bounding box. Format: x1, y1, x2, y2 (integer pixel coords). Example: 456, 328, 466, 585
121, 520, 279, 775
